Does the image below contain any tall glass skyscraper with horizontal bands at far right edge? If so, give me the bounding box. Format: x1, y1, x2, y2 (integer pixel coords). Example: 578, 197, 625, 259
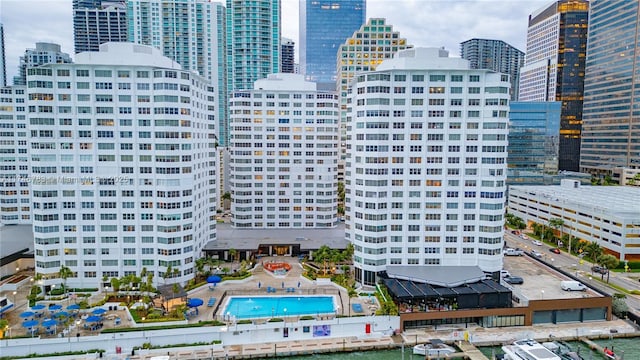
580, 0, 640, 174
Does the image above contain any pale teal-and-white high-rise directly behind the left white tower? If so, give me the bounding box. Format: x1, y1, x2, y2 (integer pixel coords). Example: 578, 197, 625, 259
127, 0, 229, 146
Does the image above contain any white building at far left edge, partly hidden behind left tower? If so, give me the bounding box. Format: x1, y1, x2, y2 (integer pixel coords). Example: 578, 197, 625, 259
0, 86, 31, 225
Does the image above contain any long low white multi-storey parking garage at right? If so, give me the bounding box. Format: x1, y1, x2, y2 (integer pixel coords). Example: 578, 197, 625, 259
509, 180, 640, 261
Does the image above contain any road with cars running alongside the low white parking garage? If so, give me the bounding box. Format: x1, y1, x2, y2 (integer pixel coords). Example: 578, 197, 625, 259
505, 230, 640, 315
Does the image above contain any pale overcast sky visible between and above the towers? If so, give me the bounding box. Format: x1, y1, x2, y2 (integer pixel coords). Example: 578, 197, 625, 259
0, 0, 550, 84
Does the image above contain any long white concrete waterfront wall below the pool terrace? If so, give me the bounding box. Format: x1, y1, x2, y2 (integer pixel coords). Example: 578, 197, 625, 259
0, 316, 400, 356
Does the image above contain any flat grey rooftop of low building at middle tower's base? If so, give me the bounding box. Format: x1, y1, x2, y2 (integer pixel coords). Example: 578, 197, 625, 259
203, 223, 348, 250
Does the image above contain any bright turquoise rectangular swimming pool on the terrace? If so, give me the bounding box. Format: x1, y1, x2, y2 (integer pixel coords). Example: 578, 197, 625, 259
223, 296, 336, 319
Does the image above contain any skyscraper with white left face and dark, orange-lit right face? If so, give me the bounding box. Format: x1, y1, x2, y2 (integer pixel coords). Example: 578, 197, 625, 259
518, 0, 589, 171
